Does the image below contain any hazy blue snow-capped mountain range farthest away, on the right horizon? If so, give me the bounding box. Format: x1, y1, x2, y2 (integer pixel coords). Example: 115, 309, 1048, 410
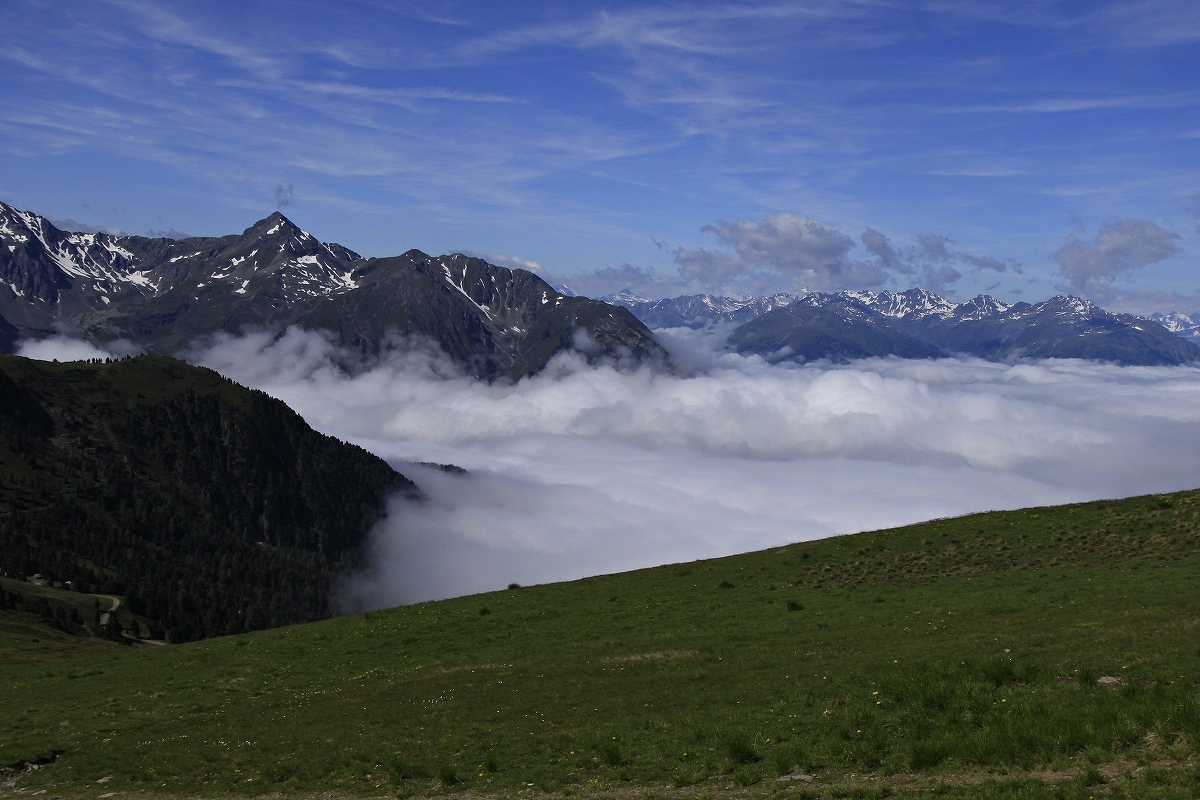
606, 289, 1200, 365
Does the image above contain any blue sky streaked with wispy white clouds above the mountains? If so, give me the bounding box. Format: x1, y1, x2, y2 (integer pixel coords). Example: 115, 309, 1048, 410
0, 0, 1200, 313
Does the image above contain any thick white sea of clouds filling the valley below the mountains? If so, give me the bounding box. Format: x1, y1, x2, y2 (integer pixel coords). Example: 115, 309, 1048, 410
20, 329, 1200, 608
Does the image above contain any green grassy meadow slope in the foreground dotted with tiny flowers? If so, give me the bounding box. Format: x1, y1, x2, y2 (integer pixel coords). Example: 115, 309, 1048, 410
0, 492, 1200, 799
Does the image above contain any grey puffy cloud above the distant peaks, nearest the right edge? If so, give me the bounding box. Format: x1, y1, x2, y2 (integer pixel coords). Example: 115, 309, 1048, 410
1051, 219, 1183, 291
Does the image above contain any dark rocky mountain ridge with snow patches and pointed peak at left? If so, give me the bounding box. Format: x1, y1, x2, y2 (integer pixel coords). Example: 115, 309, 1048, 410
0, 203, 666, 378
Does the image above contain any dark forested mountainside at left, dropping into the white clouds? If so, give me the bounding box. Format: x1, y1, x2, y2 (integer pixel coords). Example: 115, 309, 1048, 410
0, 356, 415, 642
